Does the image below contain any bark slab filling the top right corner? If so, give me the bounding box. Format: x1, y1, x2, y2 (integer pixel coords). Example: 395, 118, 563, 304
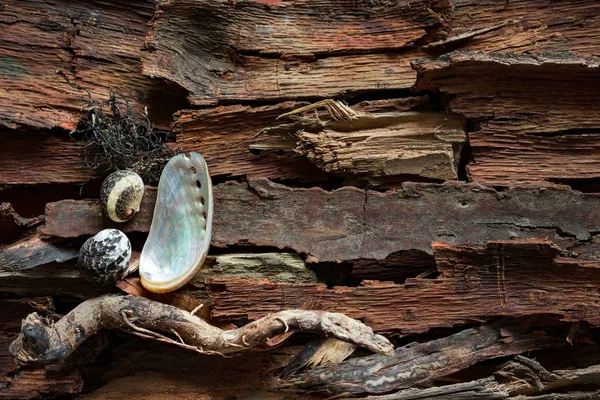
425, 0, 600, 57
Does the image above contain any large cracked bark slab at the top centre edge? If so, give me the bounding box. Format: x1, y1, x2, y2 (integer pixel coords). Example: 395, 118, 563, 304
143, 0, 451, 105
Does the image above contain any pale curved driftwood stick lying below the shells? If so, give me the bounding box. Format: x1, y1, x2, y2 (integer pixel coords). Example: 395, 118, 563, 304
9, 295, 394, 364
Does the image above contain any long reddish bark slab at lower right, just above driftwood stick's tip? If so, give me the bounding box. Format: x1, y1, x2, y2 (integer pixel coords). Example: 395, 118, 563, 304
207, 239, 600, 335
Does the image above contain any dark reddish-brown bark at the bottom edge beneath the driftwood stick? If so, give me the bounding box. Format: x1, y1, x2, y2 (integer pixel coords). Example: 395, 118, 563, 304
85, 340, 322, 400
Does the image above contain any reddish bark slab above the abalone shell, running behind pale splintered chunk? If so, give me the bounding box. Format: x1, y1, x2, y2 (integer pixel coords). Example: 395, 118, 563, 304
172, 97, 432, 183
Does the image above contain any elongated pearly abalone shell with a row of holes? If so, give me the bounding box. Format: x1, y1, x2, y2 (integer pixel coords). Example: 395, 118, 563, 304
140, 153, 213, 293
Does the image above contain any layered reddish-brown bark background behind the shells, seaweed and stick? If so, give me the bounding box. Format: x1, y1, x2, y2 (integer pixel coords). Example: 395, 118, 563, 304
0, 0, 600, 400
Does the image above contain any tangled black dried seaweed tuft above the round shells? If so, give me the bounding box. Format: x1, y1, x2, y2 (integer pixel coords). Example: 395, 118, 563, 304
71, 90, 181, 184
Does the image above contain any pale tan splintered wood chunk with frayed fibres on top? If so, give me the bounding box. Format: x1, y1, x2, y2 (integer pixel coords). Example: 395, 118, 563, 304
258, 100, 467, 185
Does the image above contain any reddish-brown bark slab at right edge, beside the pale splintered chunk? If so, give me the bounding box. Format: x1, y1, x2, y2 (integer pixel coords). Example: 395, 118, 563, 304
414, 53, 600, 185
